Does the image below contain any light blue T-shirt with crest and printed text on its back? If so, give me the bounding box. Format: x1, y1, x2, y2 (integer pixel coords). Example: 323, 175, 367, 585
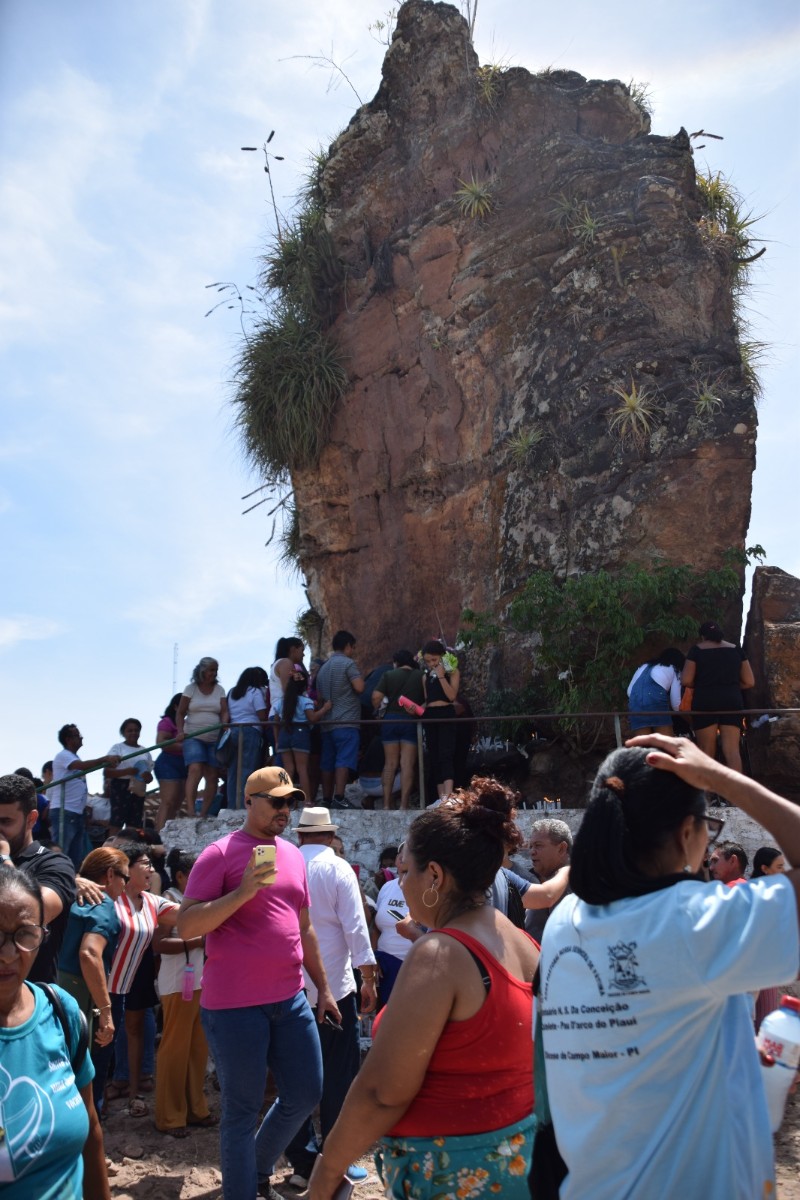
540, 876, 799, 1200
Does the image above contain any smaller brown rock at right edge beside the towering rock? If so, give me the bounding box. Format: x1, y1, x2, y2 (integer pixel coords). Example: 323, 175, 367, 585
745, 566, 800, 802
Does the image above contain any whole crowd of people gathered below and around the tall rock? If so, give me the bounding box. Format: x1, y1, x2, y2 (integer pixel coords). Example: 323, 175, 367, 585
0, 632, 800, 1200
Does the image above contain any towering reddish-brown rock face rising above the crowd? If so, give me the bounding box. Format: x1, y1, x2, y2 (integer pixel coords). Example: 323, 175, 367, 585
294, 0, 756, 664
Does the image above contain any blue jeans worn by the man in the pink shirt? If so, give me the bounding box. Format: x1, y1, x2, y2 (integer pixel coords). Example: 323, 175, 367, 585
201, 991, 323, 1200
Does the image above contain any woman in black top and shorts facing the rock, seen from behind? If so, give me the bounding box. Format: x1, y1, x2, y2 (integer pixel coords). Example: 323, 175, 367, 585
681, 620, 756, 770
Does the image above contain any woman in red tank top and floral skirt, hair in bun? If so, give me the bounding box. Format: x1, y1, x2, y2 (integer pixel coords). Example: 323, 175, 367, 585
309, 780, 539, 1200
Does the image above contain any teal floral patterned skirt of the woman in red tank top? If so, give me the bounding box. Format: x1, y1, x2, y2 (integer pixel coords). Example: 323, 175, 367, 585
375, 1115, 536, 1200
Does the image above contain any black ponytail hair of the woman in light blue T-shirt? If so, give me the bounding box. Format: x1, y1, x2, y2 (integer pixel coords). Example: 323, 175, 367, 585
570, 746, 705, 905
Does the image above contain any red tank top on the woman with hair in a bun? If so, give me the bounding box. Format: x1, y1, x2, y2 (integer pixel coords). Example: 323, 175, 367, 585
375, 929, 534, 1138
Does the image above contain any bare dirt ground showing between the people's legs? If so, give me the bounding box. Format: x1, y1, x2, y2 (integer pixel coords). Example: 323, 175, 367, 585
104, 1092, 800, 1200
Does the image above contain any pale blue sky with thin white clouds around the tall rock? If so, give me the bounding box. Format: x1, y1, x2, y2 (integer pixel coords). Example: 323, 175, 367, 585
0, 0, 800, 773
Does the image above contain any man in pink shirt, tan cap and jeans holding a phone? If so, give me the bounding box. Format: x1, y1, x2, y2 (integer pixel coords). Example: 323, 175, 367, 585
178, 767, 341, 1200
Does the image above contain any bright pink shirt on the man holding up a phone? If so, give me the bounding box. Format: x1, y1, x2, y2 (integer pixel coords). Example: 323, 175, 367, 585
185, 829, 309, 1008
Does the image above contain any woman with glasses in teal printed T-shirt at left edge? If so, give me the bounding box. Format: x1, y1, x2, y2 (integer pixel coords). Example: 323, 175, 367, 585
0, 862, 110, 1200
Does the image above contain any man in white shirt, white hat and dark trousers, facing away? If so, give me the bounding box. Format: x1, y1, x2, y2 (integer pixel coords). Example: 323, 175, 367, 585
285, 808, 377, 1189
